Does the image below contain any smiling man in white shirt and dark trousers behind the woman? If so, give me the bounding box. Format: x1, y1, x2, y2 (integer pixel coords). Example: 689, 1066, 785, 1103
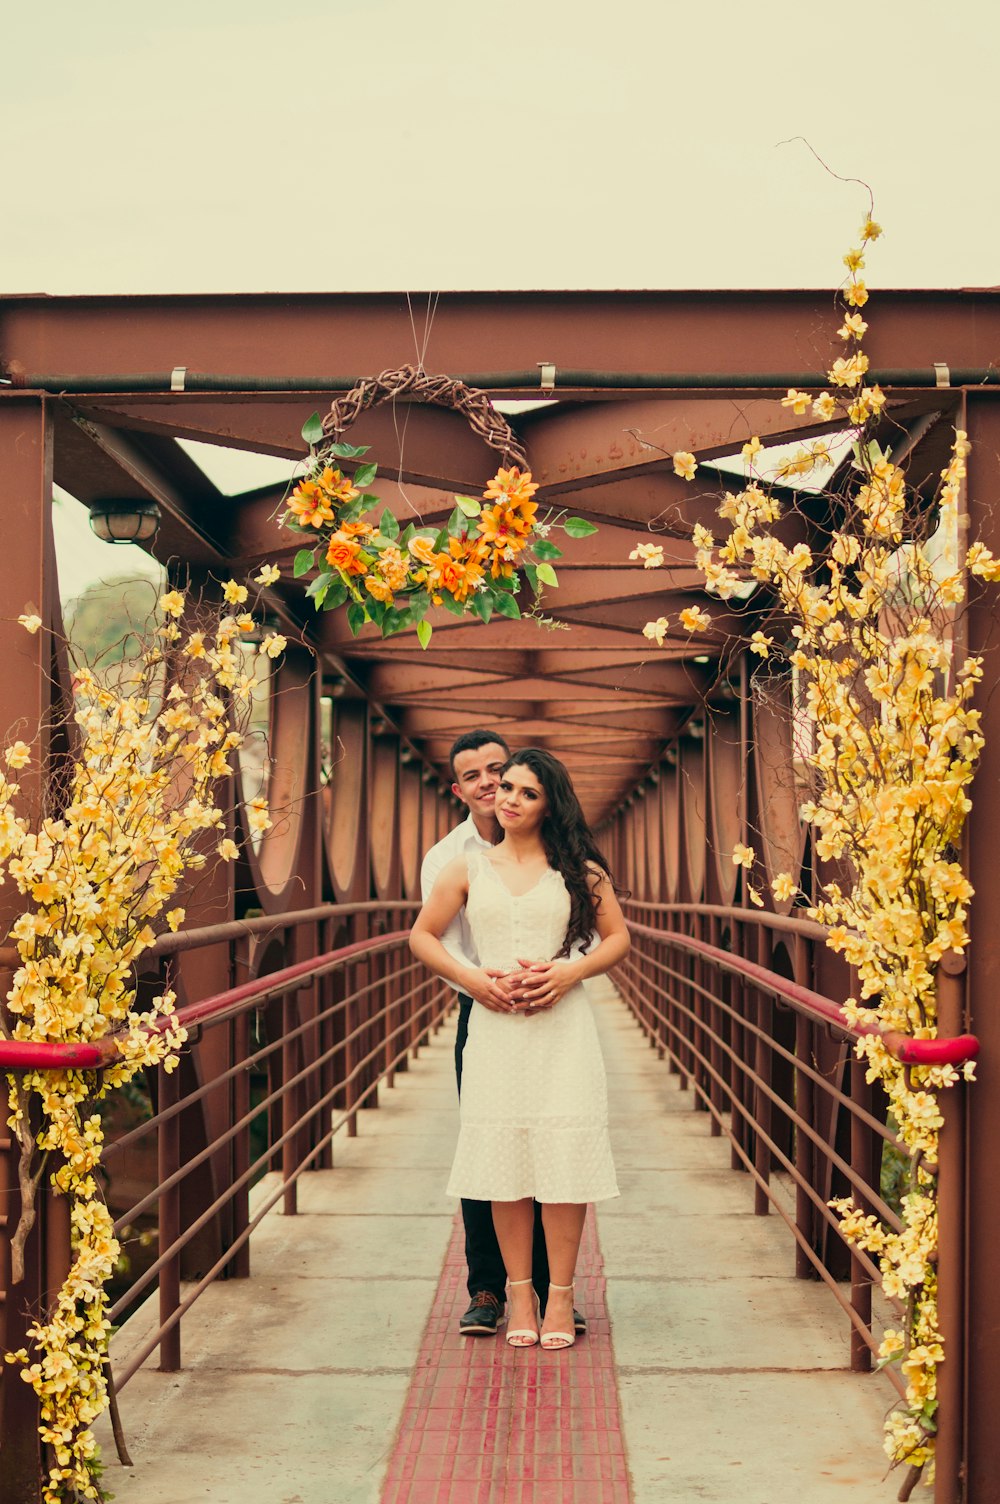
420, 731, 586, 1337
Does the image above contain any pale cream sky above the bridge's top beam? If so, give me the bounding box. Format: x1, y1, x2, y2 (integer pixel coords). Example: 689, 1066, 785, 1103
0, 0, 1000, 293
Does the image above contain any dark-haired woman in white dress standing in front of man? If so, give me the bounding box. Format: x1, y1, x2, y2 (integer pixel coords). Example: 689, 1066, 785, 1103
411, 747, 629, 1349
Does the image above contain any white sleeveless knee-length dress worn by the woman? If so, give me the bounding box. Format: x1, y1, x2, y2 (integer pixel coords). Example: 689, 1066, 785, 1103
448, 851, 618, 1203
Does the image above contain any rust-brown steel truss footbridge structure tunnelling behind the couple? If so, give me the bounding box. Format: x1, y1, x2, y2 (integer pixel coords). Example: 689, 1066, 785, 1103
0, 292, 1000, 1504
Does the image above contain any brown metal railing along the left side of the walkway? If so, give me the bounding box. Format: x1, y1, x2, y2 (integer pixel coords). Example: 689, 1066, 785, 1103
0, 902, 454, 1504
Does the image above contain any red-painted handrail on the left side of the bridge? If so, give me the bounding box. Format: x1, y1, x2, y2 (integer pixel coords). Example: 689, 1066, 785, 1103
0, 929, 409, 1071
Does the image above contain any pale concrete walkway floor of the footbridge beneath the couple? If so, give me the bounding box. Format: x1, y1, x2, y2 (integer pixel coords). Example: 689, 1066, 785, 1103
101, 990, 898, 1504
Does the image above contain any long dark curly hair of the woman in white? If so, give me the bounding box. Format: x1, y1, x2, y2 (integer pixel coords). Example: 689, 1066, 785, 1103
501, 747, 624, 955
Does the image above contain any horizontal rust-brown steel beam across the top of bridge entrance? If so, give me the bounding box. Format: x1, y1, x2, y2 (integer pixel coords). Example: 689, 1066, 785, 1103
7, 289, 1000, 394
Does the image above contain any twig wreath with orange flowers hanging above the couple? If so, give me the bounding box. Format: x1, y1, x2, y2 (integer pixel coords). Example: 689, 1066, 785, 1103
280, 367, 597, 648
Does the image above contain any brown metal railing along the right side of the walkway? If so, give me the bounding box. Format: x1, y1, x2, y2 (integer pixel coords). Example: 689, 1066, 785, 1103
615, 902, 979, 1504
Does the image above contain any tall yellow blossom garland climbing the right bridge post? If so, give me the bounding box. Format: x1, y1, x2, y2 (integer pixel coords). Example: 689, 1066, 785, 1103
633, 217, 980, 1496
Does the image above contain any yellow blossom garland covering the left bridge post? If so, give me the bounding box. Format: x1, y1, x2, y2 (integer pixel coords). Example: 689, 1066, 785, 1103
0, 577, 284, 1504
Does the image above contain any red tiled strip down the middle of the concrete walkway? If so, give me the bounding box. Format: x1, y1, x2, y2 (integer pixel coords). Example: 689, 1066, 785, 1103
382, 1208, 632, 1504
